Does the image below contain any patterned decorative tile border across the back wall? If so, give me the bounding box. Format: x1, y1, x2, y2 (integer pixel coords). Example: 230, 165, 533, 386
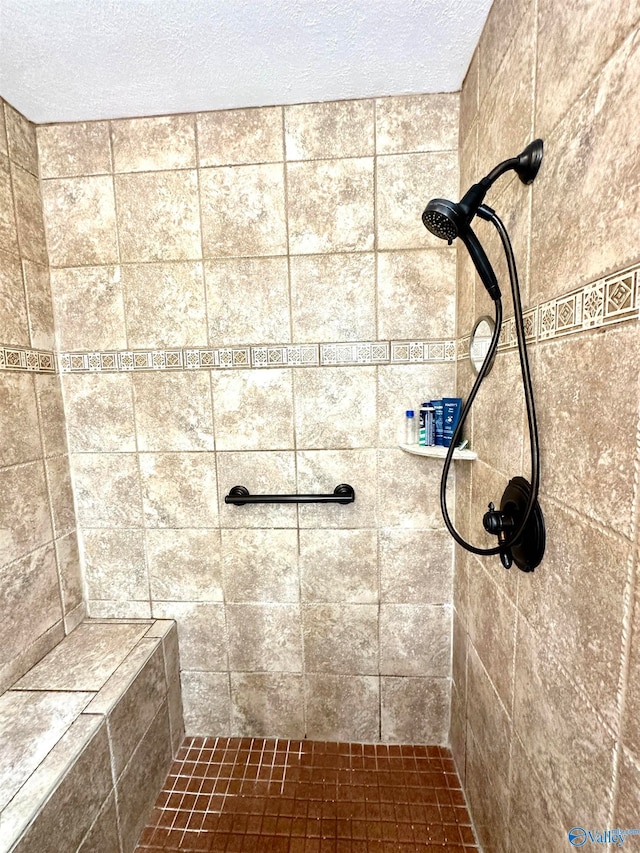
58, 340, 456, 373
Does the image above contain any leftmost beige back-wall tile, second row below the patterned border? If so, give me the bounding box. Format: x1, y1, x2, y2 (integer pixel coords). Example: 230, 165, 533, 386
71, 453, 142, 527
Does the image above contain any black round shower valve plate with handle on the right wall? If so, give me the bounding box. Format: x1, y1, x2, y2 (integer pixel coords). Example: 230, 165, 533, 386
483, 477, 546, 572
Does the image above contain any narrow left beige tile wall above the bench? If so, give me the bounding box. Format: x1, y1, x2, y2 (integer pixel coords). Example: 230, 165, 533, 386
0, 100, 84, 692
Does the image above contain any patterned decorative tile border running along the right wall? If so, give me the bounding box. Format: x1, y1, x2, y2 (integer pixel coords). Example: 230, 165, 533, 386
457, 256, 640, 359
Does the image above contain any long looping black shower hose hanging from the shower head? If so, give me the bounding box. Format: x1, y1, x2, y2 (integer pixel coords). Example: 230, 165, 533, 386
440, 204, 540, 556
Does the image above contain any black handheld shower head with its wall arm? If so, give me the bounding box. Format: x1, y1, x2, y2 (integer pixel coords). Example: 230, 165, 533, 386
422, 139, 543, 300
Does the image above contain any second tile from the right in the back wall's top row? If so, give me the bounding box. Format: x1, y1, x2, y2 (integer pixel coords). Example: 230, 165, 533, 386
284, 100, 375, 160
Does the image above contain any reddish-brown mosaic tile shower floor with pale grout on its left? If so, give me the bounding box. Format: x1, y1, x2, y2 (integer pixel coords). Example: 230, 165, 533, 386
136, 738, 477, 853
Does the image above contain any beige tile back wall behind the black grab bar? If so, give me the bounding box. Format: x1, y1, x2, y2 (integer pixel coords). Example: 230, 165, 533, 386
38, 94, 459, 744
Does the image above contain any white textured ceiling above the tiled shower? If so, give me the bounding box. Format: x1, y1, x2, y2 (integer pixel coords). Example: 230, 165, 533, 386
0, 0, 491, 123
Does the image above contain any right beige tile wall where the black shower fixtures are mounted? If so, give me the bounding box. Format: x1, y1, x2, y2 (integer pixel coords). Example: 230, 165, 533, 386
451, 0, 640, 851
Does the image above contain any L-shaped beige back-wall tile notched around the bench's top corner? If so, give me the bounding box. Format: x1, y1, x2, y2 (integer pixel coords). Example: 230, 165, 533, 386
153, 601, 228, 672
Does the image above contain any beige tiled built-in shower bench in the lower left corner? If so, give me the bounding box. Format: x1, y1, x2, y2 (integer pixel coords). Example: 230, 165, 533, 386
0, 619, 184, 853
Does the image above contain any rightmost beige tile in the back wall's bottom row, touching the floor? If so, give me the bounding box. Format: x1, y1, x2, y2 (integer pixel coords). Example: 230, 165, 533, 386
380, 676, 450, 745
